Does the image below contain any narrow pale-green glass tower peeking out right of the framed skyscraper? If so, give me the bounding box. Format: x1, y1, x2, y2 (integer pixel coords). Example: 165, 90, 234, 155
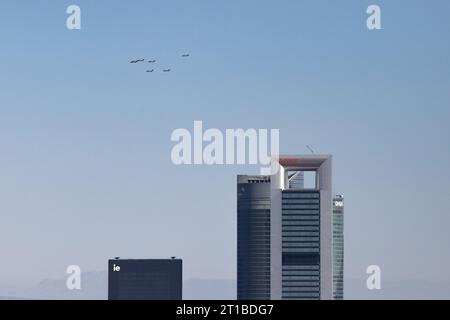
333, 195, 344, 300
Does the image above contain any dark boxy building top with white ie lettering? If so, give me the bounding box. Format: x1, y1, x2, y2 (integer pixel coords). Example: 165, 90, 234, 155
108, 258, 183, 300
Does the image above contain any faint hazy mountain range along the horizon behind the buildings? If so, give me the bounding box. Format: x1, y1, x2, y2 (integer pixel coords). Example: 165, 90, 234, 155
0, 271, 450, 300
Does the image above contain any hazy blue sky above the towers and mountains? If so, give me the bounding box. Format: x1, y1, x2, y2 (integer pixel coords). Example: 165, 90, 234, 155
0, 0, 450, 290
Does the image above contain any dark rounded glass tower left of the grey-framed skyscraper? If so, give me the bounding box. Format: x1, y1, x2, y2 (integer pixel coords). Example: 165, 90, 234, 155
237, 176, 270, 300
